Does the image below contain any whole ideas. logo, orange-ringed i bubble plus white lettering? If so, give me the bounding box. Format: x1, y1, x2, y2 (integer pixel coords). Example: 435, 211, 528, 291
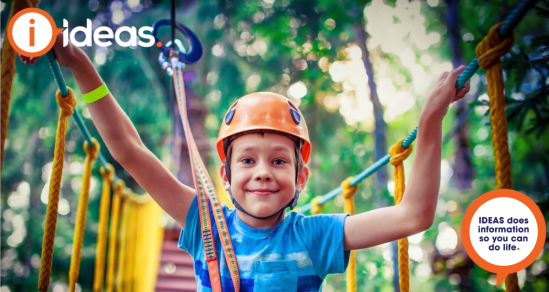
7, 8, 156, 57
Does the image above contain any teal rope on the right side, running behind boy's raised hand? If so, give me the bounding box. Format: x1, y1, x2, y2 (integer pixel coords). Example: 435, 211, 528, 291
296, 0, 537, 213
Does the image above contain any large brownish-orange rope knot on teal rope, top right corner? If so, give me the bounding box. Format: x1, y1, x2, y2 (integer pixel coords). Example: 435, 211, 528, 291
475, 22, 515, 70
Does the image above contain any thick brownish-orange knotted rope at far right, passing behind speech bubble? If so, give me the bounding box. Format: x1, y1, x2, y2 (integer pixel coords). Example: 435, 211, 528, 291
475, 22, 520, 291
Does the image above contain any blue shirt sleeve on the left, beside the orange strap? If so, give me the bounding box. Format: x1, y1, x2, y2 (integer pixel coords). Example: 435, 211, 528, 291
178, 195, 202, 257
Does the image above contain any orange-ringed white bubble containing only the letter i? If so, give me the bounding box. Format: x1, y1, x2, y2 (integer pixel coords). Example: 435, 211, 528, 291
7, 8, 64, 57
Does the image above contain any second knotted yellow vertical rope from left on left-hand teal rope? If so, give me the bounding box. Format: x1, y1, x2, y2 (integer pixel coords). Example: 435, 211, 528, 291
69, 138, 99, 292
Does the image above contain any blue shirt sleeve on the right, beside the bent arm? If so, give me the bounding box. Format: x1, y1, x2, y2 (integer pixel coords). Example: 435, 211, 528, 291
297, 214, 350, 279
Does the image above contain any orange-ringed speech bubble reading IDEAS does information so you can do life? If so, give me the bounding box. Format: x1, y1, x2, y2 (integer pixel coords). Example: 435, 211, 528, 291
461, 189, 547, 285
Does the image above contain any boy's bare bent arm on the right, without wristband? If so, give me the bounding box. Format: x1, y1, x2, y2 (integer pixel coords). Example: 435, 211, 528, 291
344, 66, 469, 250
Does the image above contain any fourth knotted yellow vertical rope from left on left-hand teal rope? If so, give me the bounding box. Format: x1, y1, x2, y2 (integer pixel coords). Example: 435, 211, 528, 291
107, 179, 122, 292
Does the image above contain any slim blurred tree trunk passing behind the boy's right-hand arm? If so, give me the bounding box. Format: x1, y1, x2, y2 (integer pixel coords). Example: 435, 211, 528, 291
355, 22, 400, 292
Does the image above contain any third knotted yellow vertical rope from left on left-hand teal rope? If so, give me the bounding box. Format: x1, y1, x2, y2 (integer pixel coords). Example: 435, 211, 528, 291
93, 164, 114, 292
